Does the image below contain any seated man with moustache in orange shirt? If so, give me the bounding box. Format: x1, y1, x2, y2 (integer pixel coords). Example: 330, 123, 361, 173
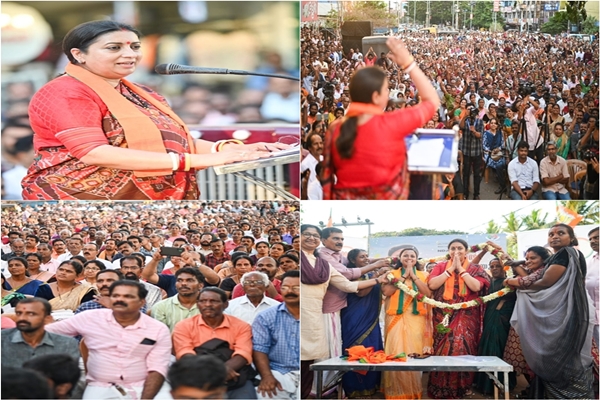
173, 287, 256, 399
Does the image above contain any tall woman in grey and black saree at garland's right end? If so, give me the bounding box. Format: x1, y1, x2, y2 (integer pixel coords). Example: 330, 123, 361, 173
506, 224, 595, 399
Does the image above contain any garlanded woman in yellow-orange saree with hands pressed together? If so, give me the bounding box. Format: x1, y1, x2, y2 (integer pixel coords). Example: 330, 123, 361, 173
377, 247, 433, 399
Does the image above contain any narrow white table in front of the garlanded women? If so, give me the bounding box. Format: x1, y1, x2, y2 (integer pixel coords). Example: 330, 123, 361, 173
310, 356, 513, 400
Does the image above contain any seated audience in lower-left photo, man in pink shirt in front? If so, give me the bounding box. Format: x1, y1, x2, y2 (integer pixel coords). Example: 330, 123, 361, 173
1, 201, 300, 399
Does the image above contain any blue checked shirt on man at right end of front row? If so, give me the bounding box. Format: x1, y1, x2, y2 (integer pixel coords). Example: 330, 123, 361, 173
252, 303, 300, 374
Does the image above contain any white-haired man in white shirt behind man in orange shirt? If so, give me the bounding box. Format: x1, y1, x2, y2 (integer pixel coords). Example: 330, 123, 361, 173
224, 271, 280, 325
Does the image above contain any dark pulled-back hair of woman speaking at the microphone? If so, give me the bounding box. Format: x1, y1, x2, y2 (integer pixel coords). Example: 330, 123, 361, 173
62, 20, 140, 64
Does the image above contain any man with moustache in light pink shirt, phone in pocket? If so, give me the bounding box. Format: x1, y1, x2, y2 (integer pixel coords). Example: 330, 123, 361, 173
46, 280, 171, 399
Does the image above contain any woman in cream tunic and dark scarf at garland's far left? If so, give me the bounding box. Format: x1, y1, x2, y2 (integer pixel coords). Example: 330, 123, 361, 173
300, 224, 387, 399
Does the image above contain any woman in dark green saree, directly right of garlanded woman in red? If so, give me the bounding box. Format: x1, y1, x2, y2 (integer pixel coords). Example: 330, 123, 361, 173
475, 258, 517, 394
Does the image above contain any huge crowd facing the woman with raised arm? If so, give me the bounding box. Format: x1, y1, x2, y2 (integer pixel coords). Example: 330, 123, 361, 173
301, 26, 600, 200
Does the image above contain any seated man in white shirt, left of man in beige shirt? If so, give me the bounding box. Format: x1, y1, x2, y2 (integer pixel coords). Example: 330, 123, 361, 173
508, 141, 540, 200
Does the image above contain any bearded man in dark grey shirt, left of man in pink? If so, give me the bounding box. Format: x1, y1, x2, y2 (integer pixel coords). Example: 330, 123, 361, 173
1, 297, 80, 368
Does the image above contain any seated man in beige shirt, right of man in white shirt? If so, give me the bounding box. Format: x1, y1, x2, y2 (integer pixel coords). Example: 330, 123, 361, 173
540, 141, 571, 200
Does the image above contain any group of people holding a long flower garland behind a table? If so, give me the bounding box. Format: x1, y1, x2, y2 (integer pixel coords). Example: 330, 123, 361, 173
300, 224, 600, 399
